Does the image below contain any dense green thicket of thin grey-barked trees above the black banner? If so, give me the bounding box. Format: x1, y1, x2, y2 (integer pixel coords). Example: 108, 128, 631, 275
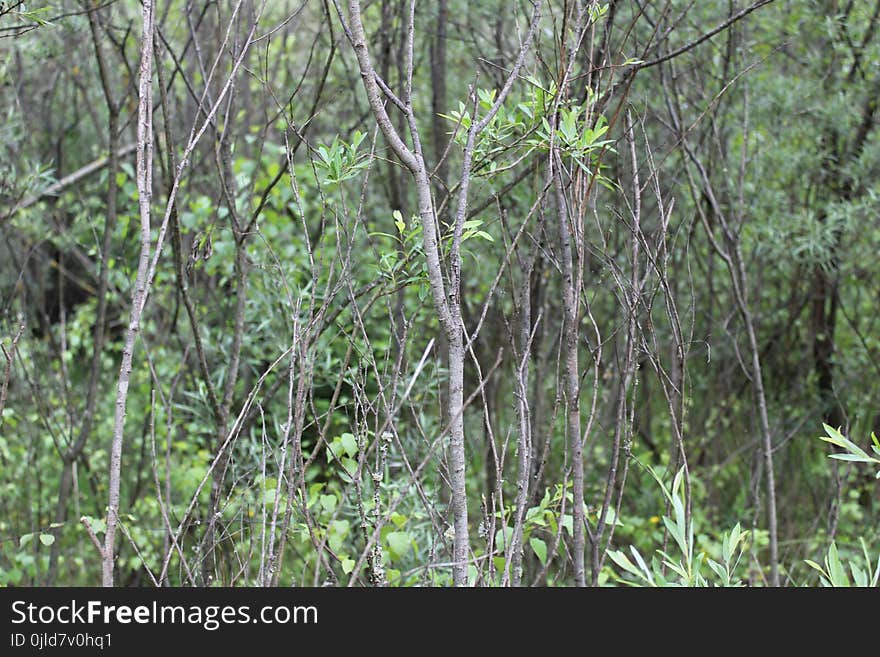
0, 0, 880, 586
